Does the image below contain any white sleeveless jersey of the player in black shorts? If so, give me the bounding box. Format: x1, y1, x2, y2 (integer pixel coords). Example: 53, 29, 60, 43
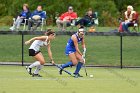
29, 36, 50, 51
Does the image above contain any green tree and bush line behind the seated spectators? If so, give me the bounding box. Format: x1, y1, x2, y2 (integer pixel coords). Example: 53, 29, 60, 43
0, 0, 140, 26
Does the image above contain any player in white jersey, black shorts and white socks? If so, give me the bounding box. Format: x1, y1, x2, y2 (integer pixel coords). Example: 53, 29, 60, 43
25, 29, 55, 77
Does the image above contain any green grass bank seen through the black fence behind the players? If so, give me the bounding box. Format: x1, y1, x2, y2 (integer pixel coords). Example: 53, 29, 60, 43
0, 35, 140, 66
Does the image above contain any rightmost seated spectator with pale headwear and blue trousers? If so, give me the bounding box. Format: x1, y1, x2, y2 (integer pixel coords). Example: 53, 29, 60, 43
119, 5, 136, 32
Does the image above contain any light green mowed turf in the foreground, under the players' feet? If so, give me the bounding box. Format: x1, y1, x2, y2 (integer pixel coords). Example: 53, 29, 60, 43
0, 65, 140, 93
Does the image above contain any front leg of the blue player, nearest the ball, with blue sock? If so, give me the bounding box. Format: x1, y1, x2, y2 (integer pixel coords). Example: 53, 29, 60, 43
74, 52, 84, 78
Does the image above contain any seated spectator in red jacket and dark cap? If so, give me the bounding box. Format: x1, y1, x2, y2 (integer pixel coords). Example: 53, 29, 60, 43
56, 6, 77, 31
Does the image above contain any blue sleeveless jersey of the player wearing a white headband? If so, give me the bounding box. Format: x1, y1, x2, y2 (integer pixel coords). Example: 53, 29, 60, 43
65, 33, 83, 55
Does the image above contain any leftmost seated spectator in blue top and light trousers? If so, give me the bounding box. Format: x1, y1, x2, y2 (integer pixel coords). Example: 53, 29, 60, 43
10, 4, 30, 31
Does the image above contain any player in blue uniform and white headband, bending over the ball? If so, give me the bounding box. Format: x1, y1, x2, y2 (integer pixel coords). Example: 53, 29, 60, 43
59, 27, 86, 78
